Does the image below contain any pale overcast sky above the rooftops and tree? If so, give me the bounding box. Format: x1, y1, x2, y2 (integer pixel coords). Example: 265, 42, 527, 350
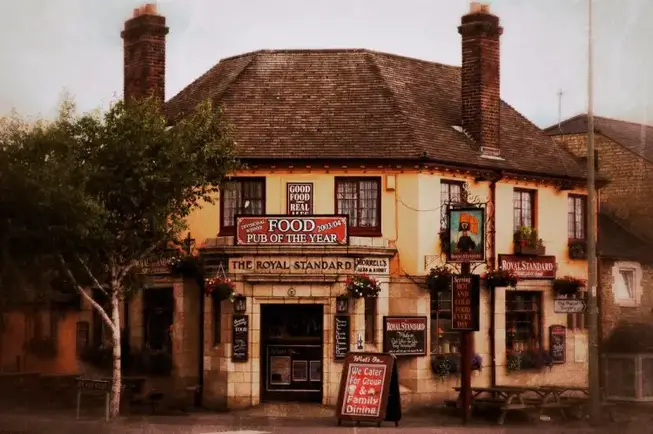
0, 0, 653, 127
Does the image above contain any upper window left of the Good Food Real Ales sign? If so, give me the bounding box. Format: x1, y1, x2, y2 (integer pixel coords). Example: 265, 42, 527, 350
220, 178, 265, 233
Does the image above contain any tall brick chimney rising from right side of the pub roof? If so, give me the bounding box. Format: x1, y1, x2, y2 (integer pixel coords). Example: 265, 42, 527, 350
458, 2, 503, 158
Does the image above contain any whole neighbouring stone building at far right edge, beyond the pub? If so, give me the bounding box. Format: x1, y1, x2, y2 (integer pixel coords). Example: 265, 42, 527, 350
546, 115, 653, 400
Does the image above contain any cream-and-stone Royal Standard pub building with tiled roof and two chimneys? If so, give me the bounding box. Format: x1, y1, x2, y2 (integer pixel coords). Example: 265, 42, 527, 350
112, 3, 587, 409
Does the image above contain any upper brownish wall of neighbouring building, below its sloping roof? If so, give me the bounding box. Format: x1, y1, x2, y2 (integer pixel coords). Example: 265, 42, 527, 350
553, 134, 653, 239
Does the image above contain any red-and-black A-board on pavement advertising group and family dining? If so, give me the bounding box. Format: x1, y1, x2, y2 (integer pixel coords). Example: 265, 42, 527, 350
336, 353, 401, 425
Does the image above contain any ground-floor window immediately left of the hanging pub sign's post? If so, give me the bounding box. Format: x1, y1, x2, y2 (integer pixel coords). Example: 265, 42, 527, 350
431, 291, 460, 354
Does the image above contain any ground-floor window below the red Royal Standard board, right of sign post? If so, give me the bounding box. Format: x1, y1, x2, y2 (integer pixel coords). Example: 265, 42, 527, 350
506, 291, 542, 353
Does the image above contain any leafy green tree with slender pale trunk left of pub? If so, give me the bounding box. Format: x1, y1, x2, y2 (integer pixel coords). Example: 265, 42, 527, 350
0, 100, 239, 416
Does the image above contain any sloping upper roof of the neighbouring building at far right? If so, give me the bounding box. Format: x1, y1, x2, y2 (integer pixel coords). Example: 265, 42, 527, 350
544, 114, 653, 163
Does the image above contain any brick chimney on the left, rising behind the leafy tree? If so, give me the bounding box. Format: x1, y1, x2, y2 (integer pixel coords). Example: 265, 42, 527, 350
120, 4, 168, 103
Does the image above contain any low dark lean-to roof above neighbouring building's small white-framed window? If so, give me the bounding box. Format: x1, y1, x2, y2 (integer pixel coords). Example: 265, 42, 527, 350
597, 213, 653, 263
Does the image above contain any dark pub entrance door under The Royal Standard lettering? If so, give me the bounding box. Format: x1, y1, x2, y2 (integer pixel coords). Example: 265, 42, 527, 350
261, 304, 323, 402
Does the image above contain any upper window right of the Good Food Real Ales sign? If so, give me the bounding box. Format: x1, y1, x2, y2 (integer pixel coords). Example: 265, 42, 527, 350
336, 178, 381, 236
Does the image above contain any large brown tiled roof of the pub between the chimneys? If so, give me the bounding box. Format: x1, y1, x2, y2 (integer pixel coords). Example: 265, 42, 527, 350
166, 50, 586, 178
